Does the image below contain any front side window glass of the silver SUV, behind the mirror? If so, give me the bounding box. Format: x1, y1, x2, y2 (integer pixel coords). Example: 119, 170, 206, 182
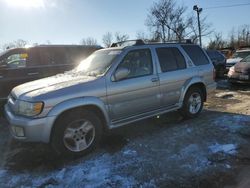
118, 49, 153, 79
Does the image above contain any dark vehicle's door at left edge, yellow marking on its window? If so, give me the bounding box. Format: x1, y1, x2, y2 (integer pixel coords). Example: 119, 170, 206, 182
0, 49, 29, 100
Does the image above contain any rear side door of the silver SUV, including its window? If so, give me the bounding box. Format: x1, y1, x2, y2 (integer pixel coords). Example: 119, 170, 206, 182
155, 47, 192, 108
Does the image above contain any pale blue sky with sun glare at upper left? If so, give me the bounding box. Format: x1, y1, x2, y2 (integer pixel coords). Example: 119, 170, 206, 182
0, 0, 250, 45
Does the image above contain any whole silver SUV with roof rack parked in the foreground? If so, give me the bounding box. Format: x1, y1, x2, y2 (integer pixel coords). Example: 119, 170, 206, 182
5, 40, 216, 155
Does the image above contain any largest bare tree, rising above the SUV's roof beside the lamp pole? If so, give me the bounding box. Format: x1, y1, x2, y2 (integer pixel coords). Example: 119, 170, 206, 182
146, 0, 210, 42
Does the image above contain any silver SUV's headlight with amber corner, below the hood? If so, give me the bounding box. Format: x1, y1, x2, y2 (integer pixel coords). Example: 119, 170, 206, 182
17, 100, 43, 116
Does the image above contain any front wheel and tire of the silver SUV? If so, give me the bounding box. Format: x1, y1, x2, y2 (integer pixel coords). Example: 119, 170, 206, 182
51, 110, 102, 156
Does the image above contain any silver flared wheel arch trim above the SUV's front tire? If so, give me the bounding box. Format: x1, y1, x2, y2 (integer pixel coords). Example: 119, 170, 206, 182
48, 97, 110, 125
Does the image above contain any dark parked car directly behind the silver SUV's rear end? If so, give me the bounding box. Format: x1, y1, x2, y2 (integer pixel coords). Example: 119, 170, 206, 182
207, 50, 227, 78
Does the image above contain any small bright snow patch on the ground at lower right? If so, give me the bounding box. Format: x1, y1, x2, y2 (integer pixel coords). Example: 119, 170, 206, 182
208, 143, 237, 155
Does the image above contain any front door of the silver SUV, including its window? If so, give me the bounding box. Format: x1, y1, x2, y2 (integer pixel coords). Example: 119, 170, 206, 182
107, 49, 160, 122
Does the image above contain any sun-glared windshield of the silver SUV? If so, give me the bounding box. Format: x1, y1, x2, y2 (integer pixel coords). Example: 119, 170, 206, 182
76, 50, 121, 76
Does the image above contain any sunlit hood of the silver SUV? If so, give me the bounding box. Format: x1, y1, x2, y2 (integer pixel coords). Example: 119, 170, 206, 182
11, 71, 96, 99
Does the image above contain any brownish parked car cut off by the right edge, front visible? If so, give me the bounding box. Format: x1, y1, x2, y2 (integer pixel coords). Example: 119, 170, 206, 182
228, 55, 250, 84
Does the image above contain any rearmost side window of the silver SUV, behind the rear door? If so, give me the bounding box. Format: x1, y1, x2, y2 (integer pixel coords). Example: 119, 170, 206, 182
182, 45, 209, 65
